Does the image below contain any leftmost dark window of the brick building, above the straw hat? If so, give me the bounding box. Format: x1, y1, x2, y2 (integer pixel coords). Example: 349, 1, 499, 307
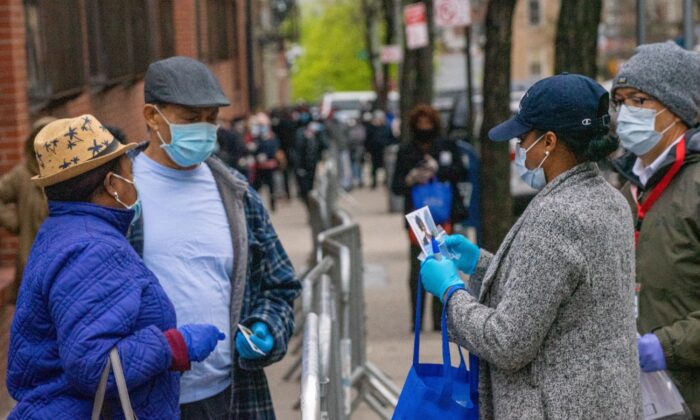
24, 0, 85, 108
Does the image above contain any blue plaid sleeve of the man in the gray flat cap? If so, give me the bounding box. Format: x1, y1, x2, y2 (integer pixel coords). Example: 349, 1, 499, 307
239, 189, 301, 369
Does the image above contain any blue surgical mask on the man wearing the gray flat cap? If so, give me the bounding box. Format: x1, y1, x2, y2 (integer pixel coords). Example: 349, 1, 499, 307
155, 107, 219, 168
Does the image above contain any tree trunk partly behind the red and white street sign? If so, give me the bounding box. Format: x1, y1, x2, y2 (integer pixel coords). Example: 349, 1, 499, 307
401, 0, 433, 141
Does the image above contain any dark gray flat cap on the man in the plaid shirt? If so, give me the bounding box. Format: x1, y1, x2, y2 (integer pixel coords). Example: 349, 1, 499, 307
143, 57, 231, 108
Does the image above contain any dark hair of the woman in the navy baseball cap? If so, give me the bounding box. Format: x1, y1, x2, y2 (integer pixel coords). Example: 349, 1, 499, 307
538, 95, 620, 162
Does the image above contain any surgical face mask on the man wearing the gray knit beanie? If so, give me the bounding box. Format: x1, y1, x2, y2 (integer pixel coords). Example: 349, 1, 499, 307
616, 105, 676, 156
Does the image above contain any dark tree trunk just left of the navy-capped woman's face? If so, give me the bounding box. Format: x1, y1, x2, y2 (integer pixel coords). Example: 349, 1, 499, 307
480, 0, 516, 251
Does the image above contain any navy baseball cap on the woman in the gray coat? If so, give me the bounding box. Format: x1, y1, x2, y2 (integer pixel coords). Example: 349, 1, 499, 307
489, 73, 610, 141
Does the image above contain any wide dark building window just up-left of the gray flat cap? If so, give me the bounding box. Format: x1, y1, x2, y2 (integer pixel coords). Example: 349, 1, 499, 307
86, 0, 174, 87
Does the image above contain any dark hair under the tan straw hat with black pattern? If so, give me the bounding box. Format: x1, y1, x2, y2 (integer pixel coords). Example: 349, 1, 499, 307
44, 156, 121, 202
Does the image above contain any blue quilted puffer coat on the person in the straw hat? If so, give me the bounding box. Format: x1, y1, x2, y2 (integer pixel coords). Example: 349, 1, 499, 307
7, 202, 180, 420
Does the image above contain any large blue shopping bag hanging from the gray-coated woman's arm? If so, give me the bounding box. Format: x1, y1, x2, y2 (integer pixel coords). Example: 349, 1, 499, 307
392, 279, 479, 420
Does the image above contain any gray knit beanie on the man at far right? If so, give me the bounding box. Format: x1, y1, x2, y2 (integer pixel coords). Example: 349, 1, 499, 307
612, 41, 700, 127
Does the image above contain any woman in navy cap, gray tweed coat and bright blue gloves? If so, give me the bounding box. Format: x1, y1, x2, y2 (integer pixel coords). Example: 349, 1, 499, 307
420, 73, 643, 420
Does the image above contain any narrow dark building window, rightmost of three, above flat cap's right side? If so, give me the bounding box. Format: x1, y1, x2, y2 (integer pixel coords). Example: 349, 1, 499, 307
205, 0, 235, 62
